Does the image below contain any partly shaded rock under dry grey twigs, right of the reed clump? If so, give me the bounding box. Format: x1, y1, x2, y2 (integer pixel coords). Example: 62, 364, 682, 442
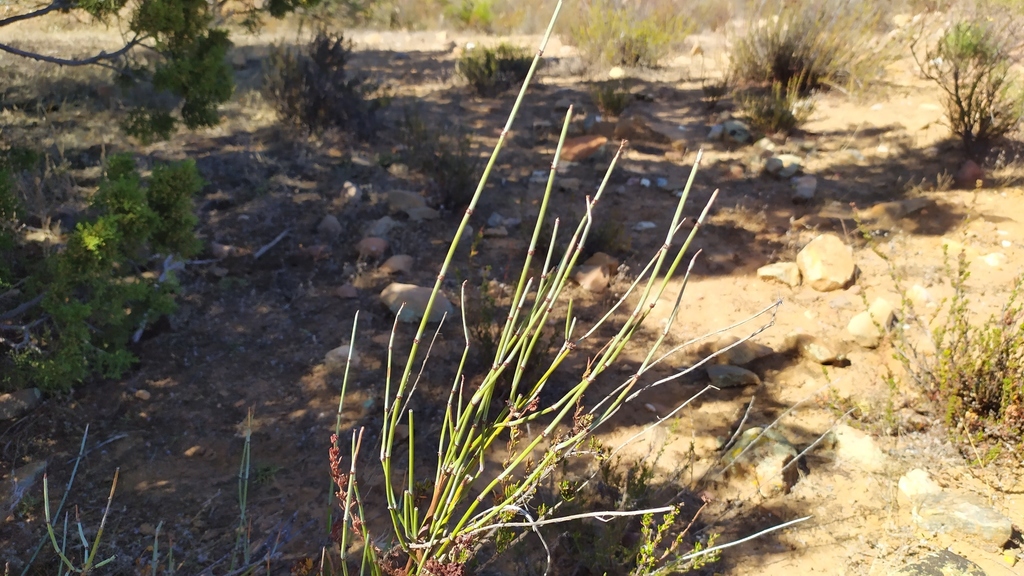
722, 427, 800, 496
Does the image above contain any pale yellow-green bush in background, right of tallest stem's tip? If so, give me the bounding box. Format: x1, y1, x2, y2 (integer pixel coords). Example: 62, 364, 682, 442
569, 0, 692, 68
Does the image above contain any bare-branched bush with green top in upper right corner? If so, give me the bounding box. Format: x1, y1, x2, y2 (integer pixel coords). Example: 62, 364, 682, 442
914, 18, 1024, 158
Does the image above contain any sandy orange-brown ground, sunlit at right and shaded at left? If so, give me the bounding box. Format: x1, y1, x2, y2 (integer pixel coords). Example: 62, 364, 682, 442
0, 15, 1024, 576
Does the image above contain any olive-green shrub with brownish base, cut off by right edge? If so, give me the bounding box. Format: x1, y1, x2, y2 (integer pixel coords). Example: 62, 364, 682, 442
924, 254, 1024, 449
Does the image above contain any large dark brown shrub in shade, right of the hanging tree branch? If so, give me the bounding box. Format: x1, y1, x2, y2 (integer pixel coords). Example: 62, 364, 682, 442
263, 32, 386, 139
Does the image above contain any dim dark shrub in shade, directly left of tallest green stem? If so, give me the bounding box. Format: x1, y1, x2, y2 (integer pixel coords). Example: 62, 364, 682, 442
399, 112, 480, 209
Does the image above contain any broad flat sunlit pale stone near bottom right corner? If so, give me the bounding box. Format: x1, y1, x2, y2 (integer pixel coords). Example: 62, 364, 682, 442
913, 492, 1014, 548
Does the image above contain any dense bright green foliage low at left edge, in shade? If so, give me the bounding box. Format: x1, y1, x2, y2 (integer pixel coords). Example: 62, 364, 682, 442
0, 155, 203, 392
